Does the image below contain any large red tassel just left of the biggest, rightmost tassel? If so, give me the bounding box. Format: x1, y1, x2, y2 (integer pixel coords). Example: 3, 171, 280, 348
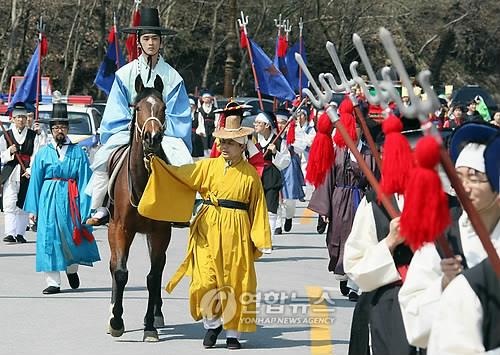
380, 114, 415, 195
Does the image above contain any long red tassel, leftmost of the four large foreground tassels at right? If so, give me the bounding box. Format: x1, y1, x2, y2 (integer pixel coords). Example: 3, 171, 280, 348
306, 112, 335, 187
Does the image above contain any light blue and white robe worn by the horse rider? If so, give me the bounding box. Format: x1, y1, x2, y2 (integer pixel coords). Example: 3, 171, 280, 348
92, 55, 192, 170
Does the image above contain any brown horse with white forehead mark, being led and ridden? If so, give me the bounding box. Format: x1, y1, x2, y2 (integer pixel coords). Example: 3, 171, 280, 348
108, 76, 171, 342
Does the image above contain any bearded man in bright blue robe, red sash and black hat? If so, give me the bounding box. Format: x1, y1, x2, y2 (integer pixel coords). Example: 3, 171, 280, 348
24, 103, 101, 294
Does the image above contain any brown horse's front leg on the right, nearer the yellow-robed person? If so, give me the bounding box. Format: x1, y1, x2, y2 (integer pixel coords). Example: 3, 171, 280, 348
144, 227, 170, 342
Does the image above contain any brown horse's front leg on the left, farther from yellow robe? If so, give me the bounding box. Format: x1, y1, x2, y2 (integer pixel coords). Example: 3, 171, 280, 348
108, 222, 134, 337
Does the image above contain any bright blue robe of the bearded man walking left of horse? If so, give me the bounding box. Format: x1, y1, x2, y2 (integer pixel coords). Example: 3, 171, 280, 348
24, 144, 101, 271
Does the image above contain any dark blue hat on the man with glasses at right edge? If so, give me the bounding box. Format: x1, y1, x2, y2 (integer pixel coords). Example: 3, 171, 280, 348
449, 122, 500, 163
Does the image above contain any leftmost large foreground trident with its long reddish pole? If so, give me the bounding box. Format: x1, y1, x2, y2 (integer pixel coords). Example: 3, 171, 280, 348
295, 53, 399, 218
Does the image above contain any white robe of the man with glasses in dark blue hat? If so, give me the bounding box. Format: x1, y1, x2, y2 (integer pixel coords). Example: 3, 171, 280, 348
399, 217, 500, 348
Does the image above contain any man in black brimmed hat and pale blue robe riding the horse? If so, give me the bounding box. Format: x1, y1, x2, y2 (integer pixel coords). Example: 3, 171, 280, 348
86, 8, 192, 225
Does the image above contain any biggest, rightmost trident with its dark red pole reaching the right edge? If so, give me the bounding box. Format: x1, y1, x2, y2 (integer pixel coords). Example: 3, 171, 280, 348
379, 28, 500, 277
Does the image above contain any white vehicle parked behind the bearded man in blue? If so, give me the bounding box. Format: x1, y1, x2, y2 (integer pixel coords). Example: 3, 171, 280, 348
38, 104, 102, 162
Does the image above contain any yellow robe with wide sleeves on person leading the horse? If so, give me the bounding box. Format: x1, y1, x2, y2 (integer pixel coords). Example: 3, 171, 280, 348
140, 157, 271, 332
